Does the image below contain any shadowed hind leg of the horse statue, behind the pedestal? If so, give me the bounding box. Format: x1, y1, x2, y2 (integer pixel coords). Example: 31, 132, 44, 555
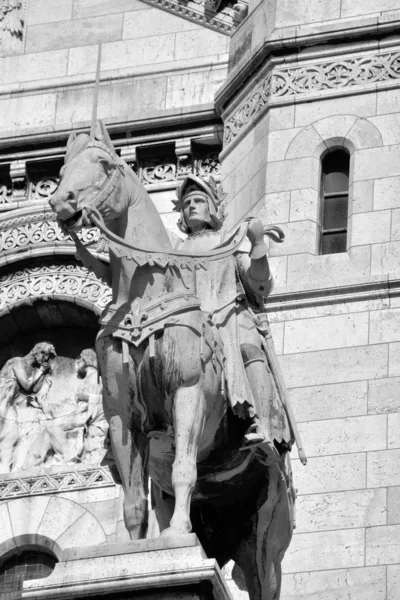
232, 463, 293, 600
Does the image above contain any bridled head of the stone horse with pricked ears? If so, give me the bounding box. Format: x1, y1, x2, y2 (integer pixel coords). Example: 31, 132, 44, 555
50, 121, 128, 231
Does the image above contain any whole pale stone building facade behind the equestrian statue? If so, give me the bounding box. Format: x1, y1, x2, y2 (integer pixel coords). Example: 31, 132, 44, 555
0, 0, 400, 600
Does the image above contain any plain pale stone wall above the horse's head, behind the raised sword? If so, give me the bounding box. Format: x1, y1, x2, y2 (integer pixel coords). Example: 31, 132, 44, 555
0, 0, 229, 140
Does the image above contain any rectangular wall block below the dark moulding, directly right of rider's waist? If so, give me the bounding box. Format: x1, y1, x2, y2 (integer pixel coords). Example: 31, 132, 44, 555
284, 312, 368, 354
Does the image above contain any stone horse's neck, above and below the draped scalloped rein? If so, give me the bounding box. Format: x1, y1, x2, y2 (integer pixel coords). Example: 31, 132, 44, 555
108, 170, 184, 305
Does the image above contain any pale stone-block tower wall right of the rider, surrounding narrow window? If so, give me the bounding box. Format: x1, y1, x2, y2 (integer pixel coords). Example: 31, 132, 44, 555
217, 2, 400, 600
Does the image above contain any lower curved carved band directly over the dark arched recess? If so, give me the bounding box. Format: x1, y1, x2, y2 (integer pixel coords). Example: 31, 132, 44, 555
0, 262, 111, 316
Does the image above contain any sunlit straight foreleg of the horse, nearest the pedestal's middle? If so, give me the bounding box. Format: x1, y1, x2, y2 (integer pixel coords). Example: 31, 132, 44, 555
161, 384, 206, 536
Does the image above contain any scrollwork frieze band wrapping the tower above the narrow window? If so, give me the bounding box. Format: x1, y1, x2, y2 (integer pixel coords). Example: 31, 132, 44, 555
224, 52, 400, 147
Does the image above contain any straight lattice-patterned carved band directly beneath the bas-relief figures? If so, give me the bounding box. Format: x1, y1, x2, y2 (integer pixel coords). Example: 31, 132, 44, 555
0, 467, 115, 500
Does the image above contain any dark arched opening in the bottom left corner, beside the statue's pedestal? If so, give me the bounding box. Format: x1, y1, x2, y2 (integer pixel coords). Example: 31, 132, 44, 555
0, 550, 58, 600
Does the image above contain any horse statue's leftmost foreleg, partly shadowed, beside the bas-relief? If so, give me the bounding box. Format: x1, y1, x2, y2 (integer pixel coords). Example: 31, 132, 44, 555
96, 337, 148, 539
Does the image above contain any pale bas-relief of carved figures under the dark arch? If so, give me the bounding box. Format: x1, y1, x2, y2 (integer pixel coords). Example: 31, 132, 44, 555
0, 342, 108, 473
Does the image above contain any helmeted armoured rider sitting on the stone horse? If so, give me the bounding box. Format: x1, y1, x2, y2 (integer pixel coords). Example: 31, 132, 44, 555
175, 175, 294, 462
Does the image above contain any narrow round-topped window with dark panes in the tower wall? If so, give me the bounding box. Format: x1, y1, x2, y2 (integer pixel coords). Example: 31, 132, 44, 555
320, 150, 350, 254
